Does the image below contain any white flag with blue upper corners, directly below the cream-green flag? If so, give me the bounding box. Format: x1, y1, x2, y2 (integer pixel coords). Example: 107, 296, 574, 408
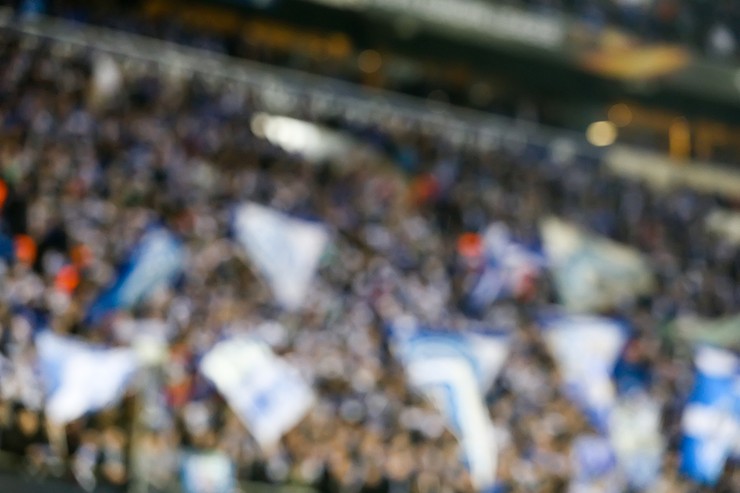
541, 315, 627, 431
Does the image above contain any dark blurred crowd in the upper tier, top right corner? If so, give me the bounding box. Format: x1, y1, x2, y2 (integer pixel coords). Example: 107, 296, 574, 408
489, 0, 740, 58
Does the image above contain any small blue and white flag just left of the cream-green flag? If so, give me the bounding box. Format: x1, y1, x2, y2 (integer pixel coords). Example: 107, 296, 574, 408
470, 223, 545, 308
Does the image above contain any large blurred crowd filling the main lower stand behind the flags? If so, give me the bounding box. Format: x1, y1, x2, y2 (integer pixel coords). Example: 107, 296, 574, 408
0, 23, 740, 493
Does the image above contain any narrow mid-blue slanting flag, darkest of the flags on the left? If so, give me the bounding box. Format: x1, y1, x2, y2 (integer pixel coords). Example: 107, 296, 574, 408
88, 228, 185, 323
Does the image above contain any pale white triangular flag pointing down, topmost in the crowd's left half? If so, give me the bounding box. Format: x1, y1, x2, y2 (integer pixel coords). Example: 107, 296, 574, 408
234, 203, 329, 310
